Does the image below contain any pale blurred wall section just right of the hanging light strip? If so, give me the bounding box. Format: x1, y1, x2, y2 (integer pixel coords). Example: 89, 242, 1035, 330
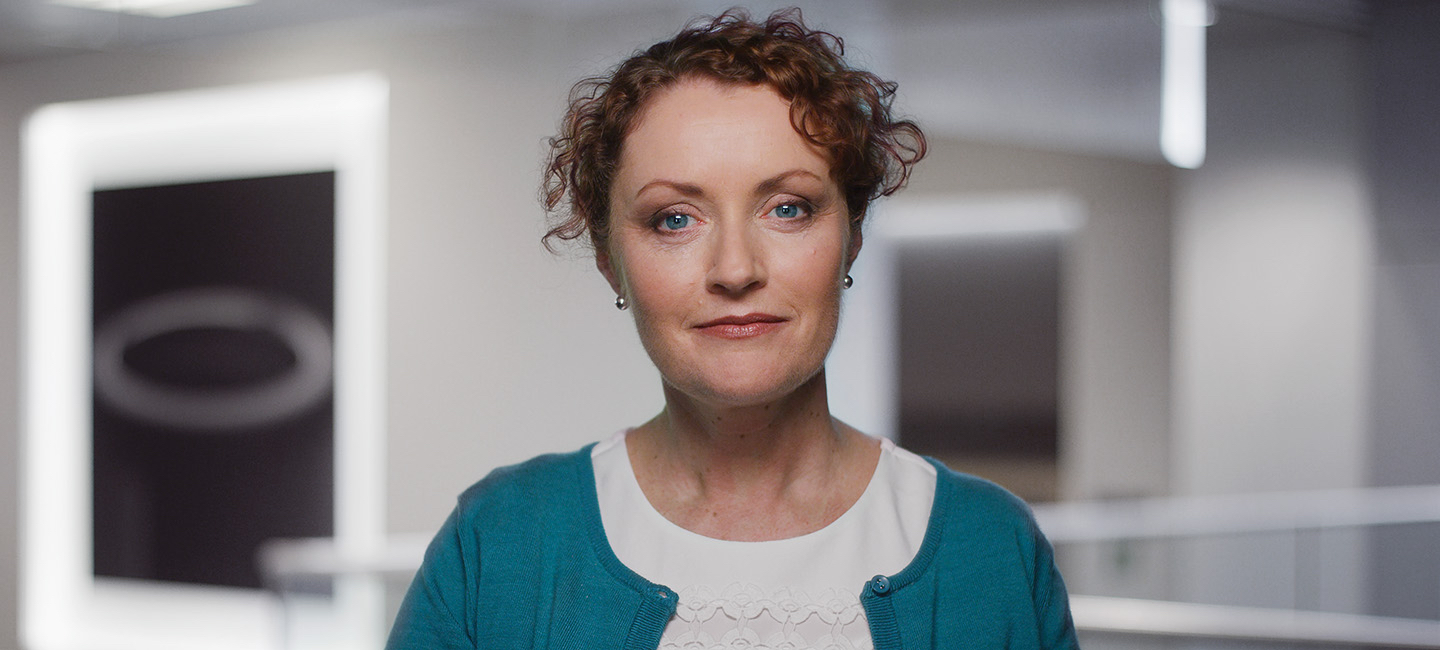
1172, 12, 1374, 610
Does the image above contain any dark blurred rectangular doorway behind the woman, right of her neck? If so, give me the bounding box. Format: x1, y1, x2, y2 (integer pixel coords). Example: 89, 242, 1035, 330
896, 233, 1064, 500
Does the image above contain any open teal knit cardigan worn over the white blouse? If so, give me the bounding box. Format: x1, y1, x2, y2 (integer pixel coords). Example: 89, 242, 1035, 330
386, 445, 1077, 650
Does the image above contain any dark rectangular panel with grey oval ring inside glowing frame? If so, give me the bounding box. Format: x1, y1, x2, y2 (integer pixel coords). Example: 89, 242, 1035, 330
92, 172, 336, 588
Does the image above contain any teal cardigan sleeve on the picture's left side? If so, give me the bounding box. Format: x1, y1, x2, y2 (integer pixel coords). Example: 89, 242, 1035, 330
384, 509, 480, 650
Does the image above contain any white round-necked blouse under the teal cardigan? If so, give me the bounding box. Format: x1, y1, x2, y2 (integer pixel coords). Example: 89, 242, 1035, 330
590, 431, 935, 650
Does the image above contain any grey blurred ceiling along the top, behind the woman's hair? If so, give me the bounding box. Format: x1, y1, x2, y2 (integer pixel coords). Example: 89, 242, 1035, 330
0, 0, 1368, 161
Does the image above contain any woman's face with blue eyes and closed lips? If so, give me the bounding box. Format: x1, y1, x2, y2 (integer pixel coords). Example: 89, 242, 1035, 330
596, 79, 860, 406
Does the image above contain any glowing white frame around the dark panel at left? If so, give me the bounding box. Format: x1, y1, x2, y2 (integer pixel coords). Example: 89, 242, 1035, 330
20, 75, 389, 650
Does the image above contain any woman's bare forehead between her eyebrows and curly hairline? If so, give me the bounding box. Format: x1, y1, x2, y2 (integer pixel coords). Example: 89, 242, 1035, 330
616, 78, 831, 182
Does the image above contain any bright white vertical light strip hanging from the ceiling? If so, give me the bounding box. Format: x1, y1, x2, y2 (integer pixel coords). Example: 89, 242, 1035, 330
1161, 0, 1211, 169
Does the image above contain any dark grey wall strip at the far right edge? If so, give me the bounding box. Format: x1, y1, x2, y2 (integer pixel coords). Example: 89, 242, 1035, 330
1368, 1, 1440, 618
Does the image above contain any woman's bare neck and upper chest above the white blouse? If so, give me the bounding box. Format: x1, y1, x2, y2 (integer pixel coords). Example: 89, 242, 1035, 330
625, 370, 880, 542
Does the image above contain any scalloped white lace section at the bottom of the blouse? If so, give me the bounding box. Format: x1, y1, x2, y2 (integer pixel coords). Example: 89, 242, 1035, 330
660, 582, 873, 650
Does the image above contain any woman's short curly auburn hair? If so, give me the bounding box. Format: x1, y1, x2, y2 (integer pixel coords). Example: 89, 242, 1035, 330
541, 9, 926, 251
